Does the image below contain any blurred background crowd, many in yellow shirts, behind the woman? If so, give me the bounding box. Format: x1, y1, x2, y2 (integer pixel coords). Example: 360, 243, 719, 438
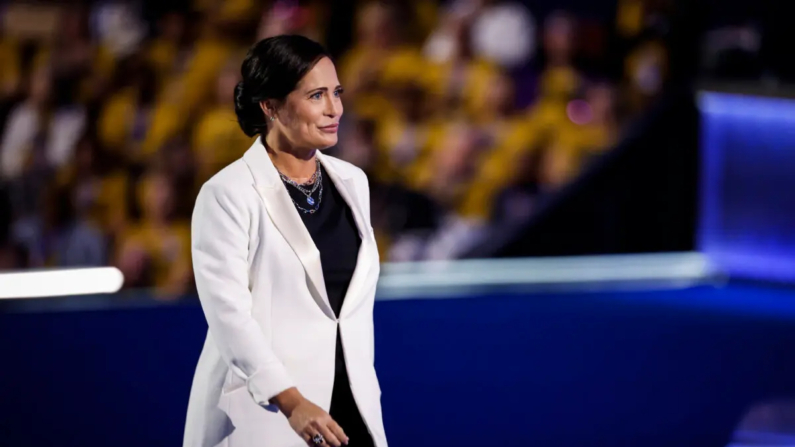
0, 0, 667, 297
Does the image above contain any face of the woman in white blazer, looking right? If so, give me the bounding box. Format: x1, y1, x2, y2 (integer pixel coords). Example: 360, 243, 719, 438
264, 57, 342, 150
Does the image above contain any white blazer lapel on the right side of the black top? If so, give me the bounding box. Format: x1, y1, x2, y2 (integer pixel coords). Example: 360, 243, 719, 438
318, 152, 375, 316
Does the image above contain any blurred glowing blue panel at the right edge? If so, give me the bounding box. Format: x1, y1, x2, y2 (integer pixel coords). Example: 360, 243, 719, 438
698, 92, 795, 281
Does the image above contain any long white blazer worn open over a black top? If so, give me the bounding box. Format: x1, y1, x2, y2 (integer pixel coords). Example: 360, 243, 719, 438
183, 139, 387, 447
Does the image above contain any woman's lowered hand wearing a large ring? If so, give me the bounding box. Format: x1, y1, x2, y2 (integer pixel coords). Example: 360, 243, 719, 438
273, 388, 348, 447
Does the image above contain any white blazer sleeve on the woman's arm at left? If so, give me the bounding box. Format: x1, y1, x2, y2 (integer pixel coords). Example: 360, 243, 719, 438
191, 184, 294, 411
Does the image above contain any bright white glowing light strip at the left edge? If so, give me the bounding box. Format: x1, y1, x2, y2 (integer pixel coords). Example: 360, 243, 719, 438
0, 267, 124, 299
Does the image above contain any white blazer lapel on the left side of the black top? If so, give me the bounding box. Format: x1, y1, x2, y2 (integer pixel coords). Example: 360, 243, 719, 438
243, 138, 336, 319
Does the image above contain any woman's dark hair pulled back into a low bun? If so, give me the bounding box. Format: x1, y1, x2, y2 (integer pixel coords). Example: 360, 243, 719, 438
235, 35, 329, 137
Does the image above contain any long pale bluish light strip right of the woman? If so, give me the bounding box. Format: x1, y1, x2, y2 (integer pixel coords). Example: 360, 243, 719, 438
378, 253, 715, 298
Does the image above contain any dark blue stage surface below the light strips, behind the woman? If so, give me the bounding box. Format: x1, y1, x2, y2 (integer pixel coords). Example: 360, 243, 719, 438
0, 284, 795, 447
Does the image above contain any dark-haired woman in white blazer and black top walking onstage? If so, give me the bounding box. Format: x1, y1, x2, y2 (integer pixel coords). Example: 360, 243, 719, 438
184, 36, 387, 447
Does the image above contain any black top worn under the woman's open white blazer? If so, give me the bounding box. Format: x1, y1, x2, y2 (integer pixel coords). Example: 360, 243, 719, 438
285, 166, 362, 374
